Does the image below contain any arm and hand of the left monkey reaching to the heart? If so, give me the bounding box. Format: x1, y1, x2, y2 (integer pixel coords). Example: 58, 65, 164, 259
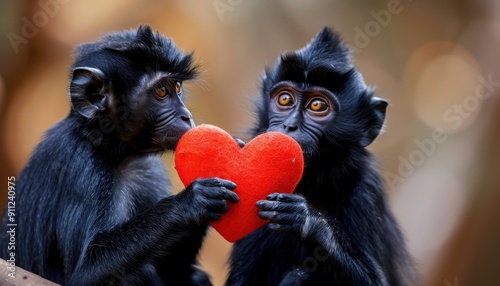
66, 179, 238, 285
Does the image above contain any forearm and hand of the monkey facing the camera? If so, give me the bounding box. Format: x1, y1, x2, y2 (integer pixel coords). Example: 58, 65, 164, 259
257, 193, 388, 285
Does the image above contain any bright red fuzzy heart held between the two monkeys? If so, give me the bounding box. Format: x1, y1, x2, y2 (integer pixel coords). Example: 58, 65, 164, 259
175, 124, 304, 242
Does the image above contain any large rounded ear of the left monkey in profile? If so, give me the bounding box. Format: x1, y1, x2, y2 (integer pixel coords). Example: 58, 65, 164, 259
69, 67, 107, 118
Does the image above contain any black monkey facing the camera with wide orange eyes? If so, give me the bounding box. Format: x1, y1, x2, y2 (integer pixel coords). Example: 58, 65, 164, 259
226, 27, 415, 286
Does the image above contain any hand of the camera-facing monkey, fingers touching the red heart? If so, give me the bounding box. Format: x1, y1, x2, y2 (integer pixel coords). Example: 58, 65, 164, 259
257, 193, 330, 240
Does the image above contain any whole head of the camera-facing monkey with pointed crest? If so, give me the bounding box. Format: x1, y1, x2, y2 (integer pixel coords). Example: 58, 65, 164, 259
255, 28, 387, 160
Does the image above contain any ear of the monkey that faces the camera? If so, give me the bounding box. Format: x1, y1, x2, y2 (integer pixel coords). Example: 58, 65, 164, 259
360, 97, 389, 147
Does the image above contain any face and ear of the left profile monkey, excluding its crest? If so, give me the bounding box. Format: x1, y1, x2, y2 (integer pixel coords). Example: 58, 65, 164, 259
71, 67, 194, 153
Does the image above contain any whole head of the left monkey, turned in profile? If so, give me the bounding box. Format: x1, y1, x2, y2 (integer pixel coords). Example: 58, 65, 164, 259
70, 26, 197, 155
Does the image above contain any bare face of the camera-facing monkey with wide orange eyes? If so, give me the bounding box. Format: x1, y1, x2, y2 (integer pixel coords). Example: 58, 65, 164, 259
268, 81, 339, 158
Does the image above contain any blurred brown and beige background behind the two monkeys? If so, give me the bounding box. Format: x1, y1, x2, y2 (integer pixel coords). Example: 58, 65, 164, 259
0, 0, 500, 286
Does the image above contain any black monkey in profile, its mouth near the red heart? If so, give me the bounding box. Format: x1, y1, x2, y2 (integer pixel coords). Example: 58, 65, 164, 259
1, 26, 238, 285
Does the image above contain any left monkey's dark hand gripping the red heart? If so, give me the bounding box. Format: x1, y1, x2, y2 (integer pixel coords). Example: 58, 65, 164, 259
178, 178, 240, 223
